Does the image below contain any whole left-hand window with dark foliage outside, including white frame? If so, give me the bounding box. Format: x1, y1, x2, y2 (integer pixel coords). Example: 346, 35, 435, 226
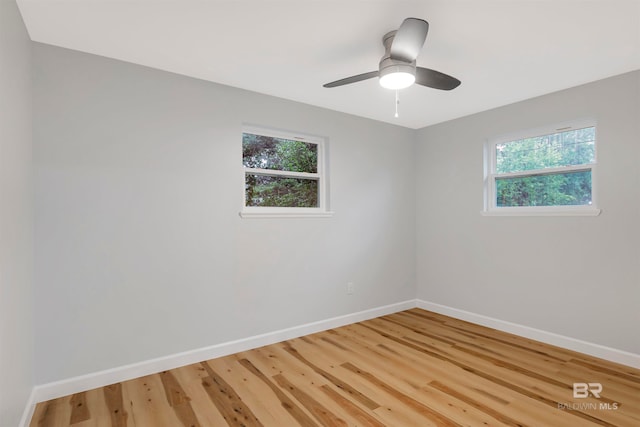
241, 126, 330, 217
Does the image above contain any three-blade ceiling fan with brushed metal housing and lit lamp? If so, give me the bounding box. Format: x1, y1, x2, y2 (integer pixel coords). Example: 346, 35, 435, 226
323, 18, 461, 90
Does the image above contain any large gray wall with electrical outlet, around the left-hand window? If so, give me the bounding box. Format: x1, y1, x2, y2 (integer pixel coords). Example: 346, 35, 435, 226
34, 44, 415, 383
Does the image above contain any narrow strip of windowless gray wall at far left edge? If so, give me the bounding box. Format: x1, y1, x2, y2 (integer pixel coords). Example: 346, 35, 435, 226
0, 0, 34, 426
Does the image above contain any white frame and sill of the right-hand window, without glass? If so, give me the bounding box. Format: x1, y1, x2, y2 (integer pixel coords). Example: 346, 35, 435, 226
481, 119, 601, 216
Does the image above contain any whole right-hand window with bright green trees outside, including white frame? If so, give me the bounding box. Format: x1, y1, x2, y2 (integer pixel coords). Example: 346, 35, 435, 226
484, 122, 600, 215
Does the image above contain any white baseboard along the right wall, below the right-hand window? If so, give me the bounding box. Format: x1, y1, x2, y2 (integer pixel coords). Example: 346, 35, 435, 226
416, 299, 640, 369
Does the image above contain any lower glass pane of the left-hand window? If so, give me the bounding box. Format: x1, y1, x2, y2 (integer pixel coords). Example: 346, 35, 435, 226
245, 174, 318, 208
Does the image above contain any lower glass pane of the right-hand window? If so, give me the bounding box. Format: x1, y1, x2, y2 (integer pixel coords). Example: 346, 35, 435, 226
496, 171, 591, 207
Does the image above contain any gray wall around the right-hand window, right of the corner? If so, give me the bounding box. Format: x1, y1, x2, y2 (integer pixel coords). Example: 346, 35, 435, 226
416, 71, 640, 353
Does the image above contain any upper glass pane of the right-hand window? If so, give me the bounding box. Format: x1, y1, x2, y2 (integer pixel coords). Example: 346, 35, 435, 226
496, 127, 596, 173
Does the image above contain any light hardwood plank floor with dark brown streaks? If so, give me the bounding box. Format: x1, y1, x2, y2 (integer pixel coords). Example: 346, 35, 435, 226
31, 309, 640, 427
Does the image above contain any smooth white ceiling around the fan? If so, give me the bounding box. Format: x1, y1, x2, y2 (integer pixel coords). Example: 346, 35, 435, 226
17, 0, 640, 128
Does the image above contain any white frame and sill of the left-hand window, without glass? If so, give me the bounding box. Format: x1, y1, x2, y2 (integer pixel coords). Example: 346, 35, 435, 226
240, 124, 333, 218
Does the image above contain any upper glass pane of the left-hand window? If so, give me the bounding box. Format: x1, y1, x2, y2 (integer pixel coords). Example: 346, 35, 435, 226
242, 133, 318, 173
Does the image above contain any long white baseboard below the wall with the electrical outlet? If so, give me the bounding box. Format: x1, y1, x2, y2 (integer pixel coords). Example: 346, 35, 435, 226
28, 300, 416, 406
